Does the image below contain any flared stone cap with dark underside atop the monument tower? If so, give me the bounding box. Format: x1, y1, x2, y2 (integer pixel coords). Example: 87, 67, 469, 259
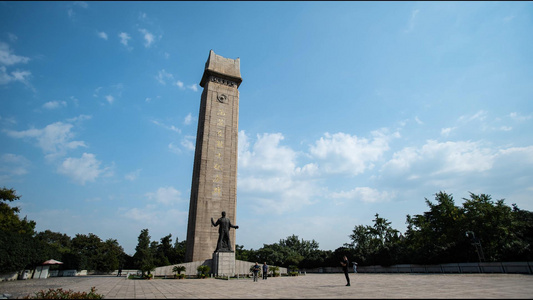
200, 50, 242, 87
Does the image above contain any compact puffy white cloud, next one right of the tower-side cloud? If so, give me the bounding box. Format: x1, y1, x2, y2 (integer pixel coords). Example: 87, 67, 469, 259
309, 131, 398, 175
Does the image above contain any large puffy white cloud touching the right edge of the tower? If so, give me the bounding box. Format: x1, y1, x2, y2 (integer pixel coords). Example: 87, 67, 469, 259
237, 131, 320, 214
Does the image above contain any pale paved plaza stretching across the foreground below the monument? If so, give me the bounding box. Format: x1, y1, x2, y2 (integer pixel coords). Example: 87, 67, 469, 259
0, 273, 533, 299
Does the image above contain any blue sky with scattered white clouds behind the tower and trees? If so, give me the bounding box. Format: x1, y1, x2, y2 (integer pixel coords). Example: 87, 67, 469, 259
0, 1, 533, 254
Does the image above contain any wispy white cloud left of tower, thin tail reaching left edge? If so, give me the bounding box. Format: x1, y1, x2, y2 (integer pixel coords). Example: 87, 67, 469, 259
4, 122, 86, 158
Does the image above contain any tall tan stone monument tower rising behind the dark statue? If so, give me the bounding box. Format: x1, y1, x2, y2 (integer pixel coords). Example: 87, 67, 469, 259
185, 50, 242, 262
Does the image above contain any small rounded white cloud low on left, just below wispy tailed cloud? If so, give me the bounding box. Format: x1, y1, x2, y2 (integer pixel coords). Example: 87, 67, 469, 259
57, 153, 105, 185
